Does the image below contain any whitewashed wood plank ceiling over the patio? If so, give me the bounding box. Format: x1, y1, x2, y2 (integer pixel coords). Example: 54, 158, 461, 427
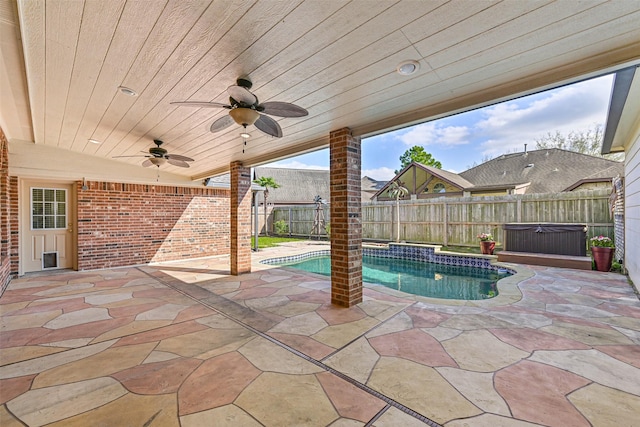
3, 0, 640, 180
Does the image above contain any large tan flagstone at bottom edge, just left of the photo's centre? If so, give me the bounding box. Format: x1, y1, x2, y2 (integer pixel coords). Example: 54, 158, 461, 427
235, 372, 339, 426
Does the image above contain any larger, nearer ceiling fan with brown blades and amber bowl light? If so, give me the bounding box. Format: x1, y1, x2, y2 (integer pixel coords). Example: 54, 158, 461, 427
171, 77, 309, 138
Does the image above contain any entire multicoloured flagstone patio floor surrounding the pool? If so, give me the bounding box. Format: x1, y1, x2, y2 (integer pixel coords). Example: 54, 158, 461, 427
0, 242, 640, 427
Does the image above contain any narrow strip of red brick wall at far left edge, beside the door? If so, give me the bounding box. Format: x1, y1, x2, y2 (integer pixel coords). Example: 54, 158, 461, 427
0, 128, 19, 295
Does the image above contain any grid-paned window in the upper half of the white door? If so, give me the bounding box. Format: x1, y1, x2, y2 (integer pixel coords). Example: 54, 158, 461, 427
31, 188, 67, 230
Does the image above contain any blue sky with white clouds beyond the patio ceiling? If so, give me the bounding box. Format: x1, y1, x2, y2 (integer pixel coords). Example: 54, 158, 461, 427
265, 76, 613, 180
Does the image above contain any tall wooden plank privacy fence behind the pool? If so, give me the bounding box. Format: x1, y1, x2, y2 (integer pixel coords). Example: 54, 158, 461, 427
269, 189, 614, 246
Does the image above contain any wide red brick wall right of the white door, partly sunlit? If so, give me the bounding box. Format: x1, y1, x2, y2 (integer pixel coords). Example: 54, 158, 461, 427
77, 182, 229, 270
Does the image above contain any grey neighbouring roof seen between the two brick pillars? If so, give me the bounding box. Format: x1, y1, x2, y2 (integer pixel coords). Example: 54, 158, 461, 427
253, 167, 331, 204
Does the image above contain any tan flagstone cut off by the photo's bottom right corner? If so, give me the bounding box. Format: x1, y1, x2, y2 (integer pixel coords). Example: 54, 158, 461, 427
569, 384, 640, 427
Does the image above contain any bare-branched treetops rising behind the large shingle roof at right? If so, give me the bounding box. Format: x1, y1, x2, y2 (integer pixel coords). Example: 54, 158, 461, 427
535, 125, 623, 160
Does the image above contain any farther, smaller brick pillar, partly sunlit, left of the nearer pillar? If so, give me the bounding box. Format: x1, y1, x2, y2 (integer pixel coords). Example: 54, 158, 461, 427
230, 162, 251, 276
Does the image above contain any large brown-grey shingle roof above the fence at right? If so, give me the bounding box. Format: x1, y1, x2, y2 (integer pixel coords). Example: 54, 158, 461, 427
460, 148, 624, 194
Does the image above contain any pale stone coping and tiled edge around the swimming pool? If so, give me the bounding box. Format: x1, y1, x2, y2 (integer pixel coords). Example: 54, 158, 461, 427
259, 243, 535, 307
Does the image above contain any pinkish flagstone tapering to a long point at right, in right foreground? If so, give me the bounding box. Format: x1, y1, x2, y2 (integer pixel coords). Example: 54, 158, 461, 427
489, 328, 590, 352
